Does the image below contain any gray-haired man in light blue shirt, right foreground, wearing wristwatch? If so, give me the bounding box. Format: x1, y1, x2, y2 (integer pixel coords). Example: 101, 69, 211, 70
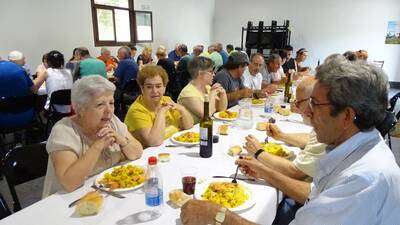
181, 55, 400, 225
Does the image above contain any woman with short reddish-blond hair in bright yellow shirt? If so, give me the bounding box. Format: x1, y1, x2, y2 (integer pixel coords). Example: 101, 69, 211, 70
125, 65, 193, 146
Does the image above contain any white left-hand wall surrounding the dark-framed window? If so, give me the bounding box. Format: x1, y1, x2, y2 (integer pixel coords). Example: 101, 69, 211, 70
0, 0, 215, 70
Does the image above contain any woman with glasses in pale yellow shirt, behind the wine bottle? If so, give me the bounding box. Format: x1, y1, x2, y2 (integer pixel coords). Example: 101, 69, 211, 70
178, 56, 228, 123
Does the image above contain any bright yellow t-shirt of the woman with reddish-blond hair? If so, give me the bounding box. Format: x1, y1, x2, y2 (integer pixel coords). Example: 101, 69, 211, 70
124, 95, 181, 139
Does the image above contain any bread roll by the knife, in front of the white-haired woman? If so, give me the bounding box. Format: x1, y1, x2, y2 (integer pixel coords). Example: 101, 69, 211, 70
75, 191, 104, 216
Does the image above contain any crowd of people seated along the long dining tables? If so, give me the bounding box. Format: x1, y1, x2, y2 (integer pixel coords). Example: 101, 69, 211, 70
0, 43, 400, 225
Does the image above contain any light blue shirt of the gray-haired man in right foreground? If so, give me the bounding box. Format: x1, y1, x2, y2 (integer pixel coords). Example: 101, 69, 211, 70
290, 129, 400, 225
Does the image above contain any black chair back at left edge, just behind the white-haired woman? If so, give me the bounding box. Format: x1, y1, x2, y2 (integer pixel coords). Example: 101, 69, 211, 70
1, 142, 49, 212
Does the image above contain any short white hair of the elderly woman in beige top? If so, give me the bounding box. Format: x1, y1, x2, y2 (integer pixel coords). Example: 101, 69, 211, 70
71, 75, 115, 111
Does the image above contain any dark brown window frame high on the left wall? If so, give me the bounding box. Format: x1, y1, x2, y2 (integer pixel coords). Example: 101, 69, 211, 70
90, 0, 154, 47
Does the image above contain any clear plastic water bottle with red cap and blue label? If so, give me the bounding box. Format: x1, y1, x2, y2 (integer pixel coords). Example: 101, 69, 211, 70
144, 156, 163, 207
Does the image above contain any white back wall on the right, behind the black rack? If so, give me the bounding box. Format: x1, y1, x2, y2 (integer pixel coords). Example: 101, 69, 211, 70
213, 0, 400, 81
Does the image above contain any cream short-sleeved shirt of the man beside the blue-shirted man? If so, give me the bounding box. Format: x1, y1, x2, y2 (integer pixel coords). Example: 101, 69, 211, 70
293, 130, 326, 177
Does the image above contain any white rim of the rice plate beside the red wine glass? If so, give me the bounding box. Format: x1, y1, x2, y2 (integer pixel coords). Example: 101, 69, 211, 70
194, 178, 256, 212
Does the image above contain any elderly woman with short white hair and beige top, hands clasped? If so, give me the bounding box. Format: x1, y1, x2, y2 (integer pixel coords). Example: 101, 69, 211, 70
43, 75, 143, 197
